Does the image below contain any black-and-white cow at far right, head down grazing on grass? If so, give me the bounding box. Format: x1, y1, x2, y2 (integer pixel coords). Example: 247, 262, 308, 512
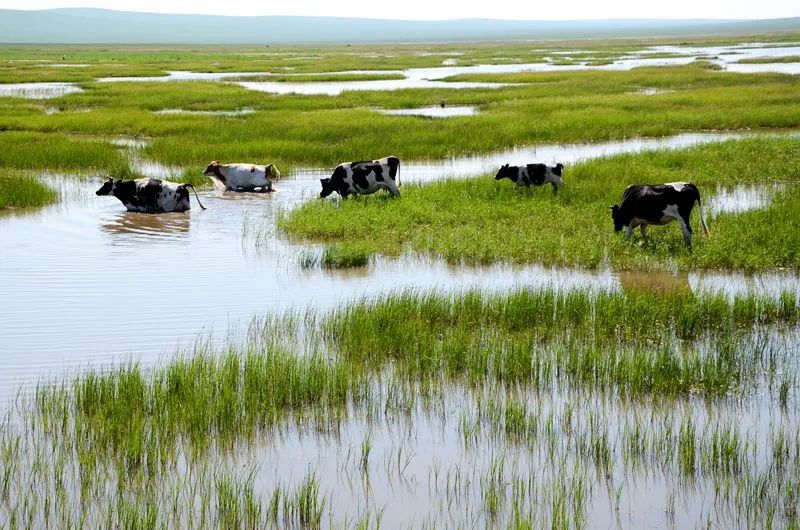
611, 182, 708, 246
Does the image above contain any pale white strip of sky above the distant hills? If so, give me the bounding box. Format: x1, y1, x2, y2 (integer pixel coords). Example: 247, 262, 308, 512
0, 0, 800, 20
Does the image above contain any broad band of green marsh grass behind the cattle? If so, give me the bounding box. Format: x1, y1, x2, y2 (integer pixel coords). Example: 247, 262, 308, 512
0, 60, 800, 168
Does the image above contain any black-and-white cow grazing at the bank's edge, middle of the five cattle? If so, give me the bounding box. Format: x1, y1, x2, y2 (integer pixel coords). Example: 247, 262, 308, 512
319, 156, 400, 198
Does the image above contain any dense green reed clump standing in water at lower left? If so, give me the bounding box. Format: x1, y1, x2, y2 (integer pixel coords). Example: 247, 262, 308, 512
47, 351, 364, 462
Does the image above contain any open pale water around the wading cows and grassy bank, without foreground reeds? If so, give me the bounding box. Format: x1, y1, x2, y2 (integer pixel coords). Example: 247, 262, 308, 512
0, 130, 800, 396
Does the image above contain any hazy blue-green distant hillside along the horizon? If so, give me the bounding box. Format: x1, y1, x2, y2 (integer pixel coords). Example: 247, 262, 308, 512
0, 8, 800, 44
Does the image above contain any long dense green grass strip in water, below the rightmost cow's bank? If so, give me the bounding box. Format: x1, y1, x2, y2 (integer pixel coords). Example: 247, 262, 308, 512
325, 290, 800, 395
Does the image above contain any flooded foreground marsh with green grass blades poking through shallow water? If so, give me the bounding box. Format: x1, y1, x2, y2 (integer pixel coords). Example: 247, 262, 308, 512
0, 290, 800, 527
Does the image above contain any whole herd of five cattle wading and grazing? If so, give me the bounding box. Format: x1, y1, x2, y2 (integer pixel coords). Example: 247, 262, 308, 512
96, 156, 708, 246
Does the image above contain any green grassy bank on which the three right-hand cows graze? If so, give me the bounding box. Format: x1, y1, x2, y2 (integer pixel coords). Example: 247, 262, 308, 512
280, 138, 800, 270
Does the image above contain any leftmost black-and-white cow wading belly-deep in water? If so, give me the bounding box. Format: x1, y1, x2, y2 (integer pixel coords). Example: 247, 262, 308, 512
95, 178, 206, 213
